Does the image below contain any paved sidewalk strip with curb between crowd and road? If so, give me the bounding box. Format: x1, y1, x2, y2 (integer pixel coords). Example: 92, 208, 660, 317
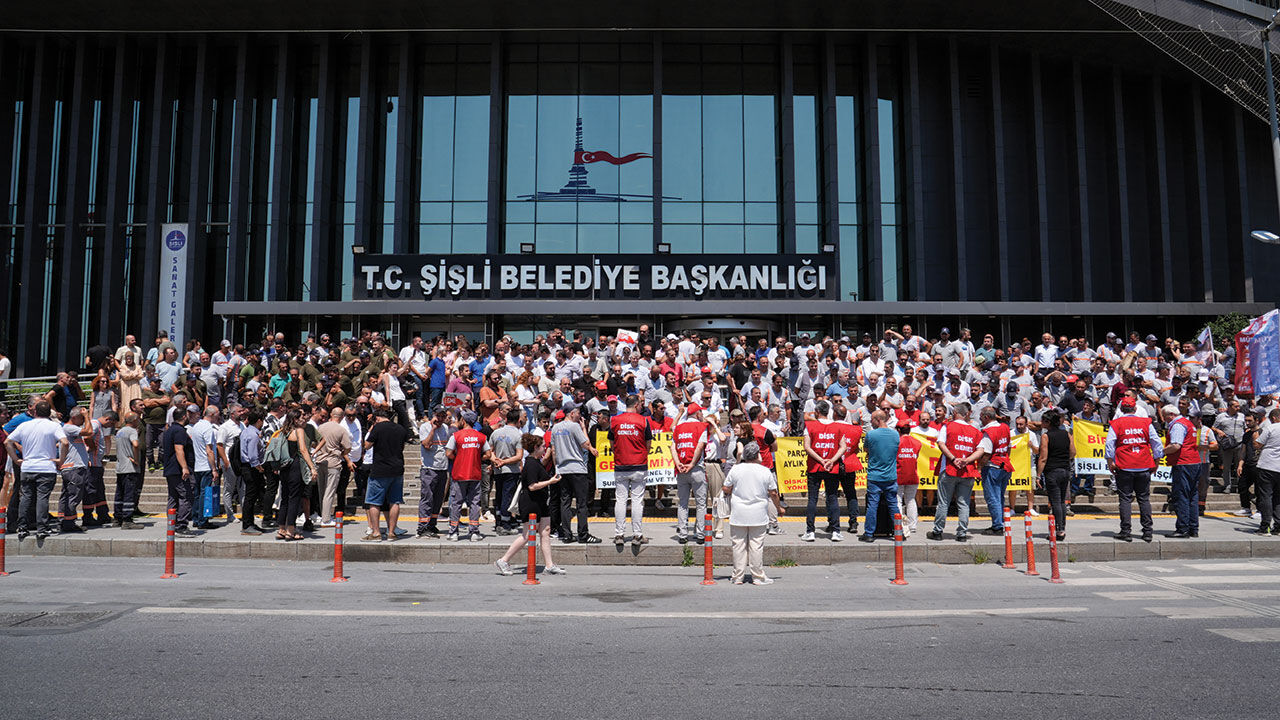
5, 512, 1280, 566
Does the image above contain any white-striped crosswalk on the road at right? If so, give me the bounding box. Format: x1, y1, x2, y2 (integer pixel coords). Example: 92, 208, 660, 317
1068, 559, 1280, 643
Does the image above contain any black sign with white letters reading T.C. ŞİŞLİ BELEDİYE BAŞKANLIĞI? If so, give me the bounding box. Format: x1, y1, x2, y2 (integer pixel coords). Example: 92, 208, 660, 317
352, 255, 840, 300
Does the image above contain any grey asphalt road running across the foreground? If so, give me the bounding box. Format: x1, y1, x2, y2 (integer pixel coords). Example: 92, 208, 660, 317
0, 557, 1280, 720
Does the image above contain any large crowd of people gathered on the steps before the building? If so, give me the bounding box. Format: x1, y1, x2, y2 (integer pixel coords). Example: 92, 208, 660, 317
3, 325, 1280, 582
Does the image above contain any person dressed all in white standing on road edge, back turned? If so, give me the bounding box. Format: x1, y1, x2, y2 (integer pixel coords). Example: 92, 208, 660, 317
724, 442, 786, 585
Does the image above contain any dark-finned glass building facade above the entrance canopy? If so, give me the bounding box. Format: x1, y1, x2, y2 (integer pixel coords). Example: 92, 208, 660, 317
0, 31, 1264, 366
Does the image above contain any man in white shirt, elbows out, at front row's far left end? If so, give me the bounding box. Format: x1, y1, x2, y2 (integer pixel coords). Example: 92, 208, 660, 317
5, 400, 70, 542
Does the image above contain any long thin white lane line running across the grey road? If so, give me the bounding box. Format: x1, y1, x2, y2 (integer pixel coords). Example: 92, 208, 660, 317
137, 607, 1089, 620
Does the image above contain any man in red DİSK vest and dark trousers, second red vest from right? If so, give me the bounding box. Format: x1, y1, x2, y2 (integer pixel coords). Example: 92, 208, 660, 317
1107, 395, 1165, 542
